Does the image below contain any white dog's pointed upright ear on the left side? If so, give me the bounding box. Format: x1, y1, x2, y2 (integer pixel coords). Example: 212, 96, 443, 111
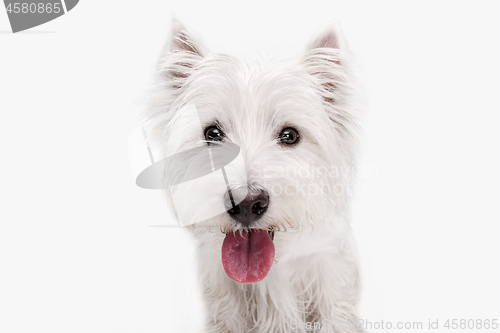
158, 19, 205, 89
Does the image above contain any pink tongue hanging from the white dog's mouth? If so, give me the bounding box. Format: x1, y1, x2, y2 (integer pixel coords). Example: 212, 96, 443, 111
222, 230, 274, 283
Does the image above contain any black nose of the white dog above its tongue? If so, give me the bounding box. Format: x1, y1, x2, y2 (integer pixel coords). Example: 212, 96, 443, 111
224, 189, 269, 225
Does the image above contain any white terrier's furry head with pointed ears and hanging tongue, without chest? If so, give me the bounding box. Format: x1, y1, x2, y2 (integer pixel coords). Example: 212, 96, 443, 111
149, 24, 354, 283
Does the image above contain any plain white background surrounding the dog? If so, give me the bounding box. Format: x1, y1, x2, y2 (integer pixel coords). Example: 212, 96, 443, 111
0, 0, 500, 333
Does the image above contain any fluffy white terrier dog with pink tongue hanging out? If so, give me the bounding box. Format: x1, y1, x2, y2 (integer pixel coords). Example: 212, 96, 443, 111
145, 22, 363, 333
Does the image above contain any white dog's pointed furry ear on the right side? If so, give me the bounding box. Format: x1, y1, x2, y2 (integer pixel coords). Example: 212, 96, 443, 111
302, 23, 356, 137
